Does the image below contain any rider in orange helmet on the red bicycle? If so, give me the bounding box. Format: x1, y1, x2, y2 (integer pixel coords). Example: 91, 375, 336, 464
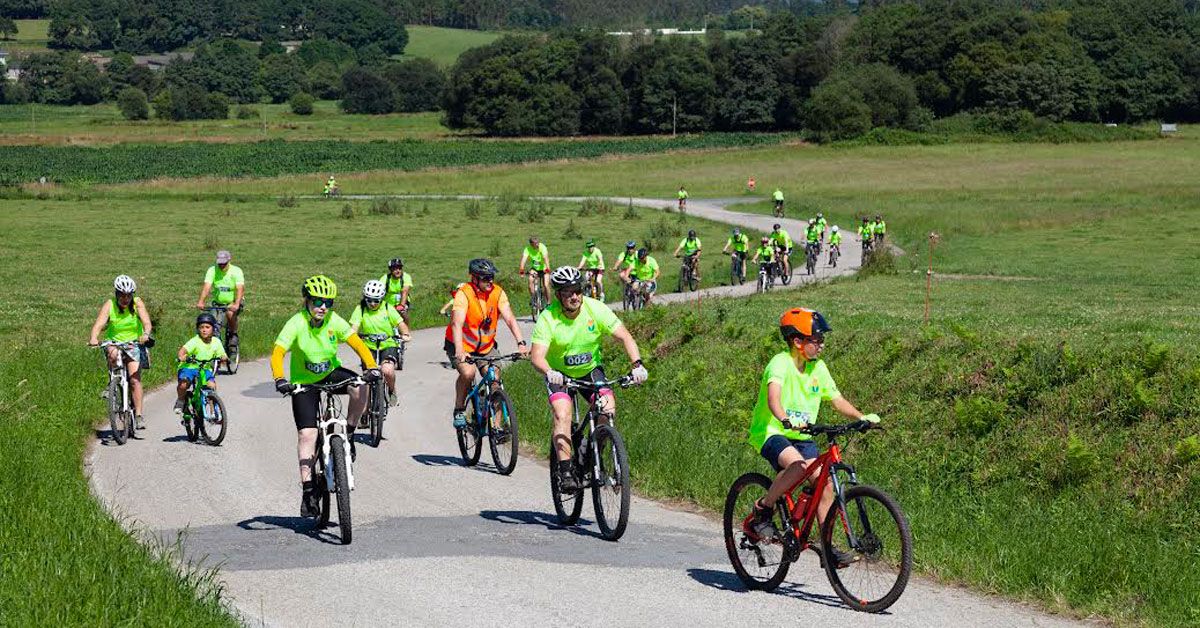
749, 307, 880, 566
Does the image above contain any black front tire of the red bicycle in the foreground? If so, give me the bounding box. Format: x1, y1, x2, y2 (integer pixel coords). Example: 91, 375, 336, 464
821, 485, 912, 612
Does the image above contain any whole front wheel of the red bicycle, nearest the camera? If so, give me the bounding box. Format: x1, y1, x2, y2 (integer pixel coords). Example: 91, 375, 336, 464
821, 485, 912, 612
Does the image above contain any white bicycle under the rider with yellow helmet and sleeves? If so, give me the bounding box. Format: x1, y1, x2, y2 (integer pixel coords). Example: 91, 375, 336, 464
289, 377, 366, 545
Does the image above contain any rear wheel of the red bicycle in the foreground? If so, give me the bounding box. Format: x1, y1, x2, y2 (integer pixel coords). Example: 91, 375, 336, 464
721, 473, 792, 591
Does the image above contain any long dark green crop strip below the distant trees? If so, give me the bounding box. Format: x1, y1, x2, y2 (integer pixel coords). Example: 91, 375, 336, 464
0, 133, 787, 184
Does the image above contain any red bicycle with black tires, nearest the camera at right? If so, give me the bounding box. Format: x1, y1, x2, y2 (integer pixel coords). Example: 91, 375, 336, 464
724, 420, 912, 612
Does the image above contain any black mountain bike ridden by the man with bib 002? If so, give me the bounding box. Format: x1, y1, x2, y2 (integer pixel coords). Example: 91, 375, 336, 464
550, 375, 634, 540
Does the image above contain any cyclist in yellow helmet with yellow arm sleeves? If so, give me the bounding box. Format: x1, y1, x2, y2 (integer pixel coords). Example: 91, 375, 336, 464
271, 275, 379, 518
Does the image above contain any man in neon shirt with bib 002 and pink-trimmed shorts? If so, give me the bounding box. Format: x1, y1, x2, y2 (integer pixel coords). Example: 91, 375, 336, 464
530, 267, 648, 492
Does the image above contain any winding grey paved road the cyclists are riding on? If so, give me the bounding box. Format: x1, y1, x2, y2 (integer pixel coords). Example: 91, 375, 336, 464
86, 199, 1068, 627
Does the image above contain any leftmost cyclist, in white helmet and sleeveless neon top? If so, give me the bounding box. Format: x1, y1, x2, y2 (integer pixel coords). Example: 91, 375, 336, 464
88, 275, 154, 430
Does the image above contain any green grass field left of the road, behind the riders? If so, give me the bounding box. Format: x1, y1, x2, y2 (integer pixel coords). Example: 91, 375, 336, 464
0, 197, 739, 626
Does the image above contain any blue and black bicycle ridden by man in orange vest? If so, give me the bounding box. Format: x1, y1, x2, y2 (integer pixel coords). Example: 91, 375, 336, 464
455, 353, 522, 476
